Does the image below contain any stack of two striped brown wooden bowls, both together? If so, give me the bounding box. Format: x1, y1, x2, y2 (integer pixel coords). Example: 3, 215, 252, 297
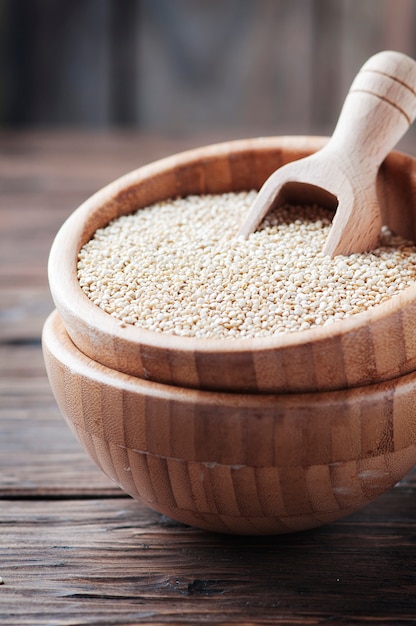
43, 137, 416, 534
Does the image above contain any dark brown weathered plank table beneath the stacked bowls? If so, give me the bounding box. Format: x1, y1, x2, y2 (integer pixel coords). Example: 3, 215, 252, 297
0, 131, 416, 626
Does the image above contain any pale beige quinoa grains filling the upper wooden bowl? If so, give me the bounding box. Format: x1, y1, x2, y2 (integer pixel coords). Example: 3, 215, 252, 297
78, 191, 416, 339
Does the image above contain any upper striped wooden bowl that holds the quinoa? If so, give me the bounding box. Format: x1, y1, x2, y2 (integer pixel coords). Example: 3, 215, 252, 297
49, 137, 416, 393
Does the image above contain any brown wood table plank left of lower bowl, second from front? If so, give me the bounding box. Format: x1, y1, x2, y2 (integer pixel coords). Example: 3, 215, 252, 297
0, 342, 121, 497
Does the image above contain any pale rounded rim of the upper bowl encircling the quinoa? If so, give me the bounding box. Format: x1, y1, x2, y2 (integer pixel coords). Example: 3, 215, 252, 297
48, 135, 416, 354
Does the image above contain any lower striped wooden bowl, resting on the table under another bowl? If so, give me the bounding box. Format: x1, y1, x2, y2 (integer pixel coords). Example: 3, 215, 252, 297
43, 312, 416, 534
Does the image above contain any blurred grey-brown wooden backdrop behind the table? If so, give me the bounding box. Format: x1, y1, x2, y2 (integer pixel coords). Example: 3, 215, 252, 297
0, 0, 416, 139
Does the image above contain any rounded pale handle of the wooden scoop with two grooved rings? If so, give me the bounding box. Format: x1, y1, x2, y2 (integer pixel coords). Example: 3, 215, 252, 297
327, 50, 416, 167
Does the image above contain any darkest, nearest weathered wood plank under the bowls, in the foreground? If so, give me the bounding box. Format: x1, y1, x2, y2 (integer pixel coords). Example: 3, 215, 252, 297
0, 490, 416, 626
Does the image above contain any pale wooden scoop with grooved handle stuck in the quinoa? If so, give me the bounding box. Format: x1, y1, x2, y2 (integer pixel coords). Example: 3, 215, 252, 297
239, 51, 416, 256
